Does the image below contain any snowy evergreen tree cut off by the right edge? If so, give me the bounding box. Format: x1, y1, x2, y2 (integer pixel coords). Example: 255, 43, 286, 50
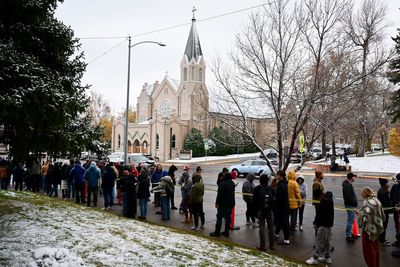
387, 29, 400, 122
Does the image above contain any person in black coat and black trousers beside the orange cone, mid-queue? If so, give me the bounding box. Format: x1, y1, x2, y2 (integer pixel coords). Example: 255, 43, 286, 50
210, 173, 236, 237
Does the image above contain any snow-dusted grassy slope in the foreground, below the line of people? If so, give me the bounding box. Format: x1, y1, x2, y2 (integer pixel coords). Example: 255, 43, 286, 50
0, 191, 297, 267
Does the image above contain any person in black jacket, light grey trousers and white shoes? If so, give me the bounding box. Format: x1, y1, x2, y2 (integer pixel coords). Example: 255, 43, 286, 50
306, 192, 335, 264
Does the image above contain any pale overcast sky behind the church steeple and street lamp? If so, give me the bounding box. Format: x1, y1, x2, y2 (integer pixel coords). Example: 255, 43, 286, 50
56, 0, 400, 113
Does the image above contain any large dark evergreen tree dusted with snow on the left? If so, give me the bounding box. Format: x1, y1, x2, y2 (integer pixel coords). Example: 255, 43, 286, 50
0, 0, 99, 160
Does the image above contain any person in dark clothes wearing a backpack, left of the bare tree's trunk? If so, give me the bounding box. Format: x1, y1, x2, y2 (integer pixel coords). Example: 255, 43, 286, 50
253, 174, 275, 251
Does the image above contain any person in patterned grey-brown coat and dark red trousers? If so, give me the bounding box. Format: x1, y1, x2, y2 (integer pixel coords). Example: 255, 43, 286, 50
358, 187, 385, 267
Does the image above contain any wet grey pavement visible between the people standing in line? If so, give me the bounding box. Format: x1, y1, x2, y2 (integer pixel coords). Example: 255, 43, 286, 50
53, 159, 400, 266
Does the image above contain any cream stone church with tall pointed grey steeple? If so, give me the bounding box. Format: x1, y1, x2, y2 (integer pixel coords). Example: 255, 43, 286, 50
112, 16, 273, 161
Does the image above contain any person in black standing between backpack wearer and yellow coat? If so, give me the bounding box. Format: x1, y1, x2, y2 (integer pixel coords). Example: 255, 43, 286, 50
275, 170, 290, 245
